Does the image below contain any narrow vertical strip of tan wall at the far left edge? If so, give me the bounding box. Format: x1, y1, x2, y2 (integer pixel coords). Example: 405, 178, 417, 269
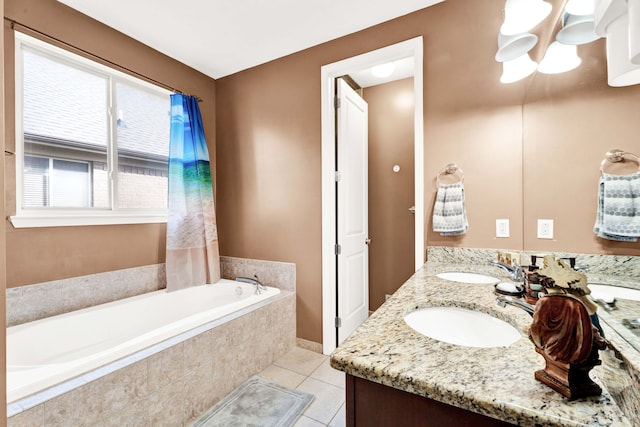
0, 0, 7, 420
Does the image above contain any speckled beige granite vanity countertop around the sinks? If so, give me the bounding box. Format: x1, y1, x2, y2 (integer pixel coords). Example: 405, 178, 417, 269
331, 262, 635, 426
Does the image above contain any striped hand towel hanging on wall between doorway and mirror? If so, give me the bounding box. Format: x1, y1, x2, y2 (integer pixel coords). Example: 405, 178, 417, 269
433, 182, 469, 236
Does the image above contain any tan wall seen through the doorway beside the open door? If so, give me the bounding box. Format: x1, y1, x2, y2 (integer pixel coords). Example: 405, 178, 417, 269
363, 78, 415, 310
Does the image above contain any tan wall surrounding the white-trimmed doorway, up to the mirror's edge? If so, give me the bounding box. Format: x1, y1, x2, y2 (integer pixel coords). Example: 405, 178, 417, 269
216, 0, 525, 342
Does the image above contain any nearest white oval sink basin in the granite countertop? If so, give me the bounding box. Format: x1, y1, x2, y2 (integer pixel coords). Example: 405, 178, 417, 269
404, 307, 521, 348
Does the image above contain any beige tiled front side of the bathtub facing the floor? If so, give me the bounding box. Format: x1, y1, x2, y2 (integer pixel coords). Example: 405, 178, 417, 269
7, 292, 295, 427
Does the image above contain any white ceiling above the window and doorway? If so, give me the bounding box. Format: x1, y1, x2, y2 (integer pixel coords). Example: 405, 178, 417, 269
58, 0, 444, 79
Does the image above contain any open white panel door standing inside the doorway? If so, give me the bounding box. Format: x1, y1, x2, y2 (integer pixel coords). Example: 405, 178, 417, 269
336, 79, 369, 344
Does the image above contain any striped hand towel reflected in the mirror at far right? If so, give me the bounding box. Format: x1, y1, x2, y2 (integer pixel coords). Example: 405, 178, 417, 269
593, 172, 640, 242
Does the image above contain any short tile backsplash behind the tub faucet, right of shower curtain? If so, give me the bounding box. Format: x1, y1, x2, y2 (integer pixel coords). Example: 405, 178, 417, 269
220, 256, 296, 292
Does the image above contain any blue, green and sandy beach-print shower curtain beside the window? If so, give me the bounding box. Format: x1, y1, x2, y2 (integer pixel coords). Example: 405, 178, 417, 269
166, 94, 220, 291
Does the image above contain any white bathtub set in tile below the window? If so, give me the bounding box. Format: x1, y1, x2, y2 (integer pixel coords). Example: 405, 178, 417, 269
7, 279, 280, 403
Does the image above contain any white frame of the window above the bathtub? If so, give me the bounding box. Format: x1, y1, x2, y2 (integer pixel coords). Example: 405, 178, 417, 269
9, 32, 171, 228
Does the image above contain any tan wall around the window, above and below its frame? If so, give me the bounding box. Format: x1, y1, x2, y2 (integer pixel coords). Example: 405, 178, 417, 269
4, 0, 216, 287
